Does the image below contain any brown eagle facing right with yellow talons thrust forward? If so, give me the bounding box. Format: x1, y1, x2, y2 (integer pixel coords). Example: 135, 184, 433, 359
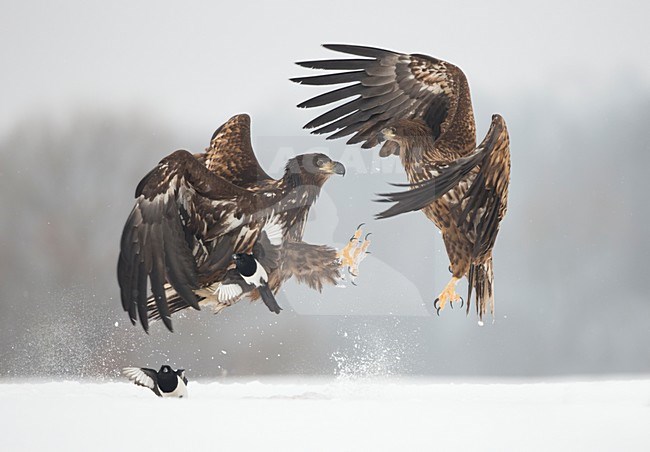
117, 114, 367, 331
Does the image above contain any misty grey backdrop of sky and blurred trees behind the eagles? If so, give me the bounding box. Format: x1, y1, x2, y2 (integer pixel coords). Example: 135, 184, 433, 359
0, 1, 650, 378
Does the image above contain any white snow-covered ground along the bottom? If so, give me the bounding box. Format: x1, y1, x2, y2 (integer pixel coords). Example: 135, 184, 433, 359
0, 379, 650, 451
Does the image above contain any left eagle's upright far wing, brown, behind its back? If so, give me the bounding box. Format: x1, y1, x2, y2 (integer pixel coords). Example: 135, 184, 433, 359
204, 114, 272, 187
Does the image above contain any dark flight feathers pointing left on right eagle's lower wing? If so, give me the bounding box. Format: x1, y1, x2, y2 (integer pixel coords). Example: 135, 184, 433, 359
375, 149, 485, 219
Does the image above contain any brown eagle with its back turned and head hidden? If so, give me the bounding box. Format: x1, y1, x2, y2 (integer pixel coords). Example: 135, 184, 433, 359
292, 45, 510, 319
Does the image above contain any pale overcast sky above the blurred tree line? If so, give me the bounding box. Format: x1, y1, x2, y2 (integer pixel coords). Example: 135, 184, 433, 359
0, 0, 650, 136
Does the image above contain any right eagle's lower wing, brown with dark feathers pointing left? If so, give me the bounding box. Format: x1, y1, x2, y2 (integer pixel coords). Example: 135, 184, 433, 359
377, 115, 510, 257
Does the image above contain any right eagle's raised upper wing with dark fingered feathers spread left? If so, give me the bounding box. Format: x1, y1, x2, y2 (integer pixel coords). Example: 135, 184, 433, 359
291, 44, 468, 156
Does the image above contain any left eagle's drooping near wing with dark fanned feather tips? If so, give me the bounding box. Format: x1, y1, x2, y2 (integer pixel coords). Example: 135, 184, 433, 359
117, 151, 277, 331
